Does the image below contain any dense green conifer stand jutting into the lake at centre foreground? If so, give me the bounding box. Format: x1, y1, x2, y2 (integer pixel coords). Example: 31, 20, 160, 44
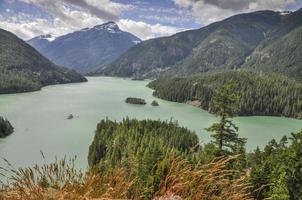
88, 119, 199, 199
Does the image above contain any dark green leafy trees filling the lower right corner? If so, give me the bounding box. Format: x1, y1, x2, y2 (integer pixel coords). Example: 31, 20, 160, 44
247, 131, 302, 200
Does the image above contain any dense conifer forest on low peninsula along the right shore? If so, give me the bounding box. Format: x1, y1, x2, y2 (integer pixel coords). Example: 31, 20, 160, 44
148, 71, 302, 119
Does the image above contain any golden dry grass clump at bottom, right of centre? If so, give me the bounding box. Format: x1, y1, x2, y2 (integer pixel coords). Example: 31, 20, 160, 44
156, 157, 253, 200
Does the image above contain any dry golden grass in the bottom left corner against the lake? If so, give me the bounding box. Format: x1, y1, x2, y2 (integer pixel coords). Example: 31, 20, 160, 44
0, 158, 135, 200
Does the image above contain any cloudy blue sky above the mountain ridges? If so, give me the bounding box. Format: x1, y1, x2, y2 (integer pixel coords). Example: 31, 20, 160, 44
0, 0, 302, 40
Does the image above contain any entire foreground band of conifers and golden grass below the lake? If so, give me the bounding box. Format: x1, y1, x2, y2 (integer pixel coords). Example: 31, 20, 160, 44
0, 119, 302, 200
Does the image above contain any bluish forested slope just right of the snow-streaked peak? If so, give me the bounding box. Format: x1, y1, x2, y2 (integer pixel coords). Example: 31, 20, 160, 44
95, 24, 216, 77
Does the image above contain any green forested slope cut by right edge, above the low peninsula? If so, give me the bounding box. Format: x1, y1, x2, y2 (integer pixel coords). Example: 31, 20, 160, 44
243, 25, 302, 80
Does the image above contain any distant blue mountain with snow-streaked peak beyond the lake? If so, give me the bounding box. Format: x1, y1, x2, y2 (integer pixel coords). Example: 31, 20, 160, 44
28, 22, 141, 73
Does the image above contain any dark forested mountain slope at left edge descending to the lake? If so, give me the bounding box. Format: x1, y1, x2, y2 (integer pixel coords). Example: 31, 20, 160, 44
0, 29, 86, 94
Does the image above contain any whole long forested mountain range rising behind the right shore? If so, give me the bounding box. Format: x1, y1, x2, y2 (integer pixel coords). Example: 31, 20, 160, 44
94, 9, 302, 79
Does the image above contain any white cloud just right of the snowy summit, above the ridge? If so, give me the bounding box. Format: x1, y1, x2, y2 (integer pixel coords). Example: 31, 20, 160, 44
118, 19, 184, 40
